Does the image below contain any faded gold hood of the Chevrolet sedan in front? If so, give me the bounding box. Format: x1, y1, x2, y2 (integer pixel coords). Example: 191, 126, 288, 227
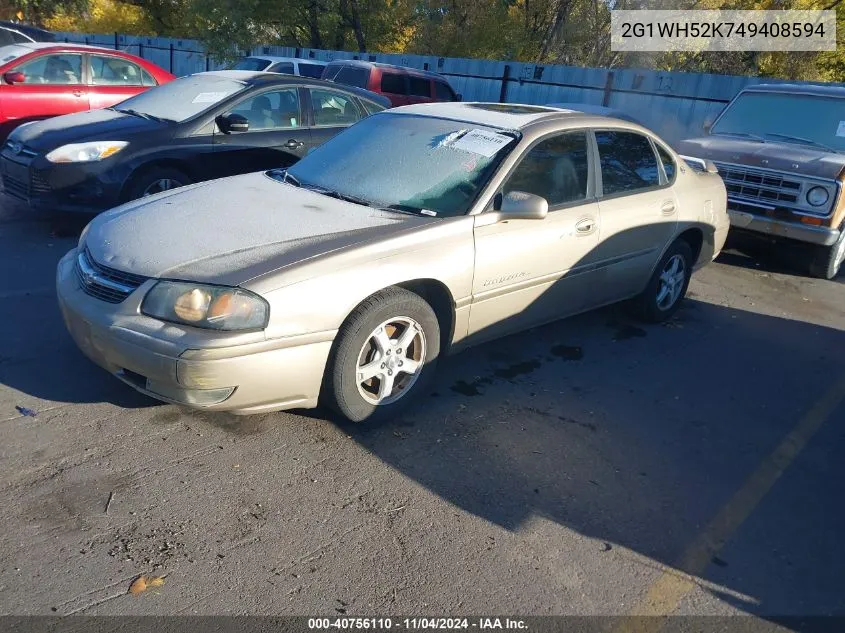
85, 173, 437, 286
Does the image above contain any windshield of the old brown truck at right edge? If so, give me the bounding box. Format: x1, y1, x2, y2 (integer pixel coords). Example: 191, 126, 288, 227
711, 92, 845, 152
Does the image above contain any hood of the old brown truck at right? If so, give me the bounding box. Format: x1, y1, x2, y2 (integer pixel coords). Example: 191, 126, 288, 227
675, 134, 845, 179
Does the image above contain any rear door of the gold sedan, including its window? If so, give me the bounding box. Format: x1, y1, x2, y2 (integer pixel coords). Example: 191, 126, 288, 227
595, 130, 678, 303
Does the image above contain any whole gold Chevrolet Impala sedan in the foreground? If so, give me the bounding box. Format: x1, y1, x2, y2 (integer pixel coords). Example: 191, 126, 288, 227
57, 103, 729, 422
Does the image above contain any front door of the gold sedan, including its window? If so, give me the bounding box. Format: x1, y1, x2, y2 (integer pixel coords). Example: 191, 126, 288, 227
469, 130, 599, 342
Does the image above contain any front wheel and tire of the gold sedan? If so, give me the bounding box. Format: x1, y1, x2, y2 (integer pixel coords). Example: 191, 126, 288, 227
323, 287, 440, 423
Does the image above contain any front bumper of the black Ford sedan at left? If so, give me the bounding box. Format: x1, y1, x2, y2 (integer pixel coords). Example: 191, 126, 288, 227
0, 149, 128, 214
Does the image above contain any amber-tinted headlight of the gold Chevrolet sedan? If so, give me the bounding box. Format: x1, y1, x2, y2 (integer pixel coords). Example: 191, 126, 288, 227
141, 281, 270, 331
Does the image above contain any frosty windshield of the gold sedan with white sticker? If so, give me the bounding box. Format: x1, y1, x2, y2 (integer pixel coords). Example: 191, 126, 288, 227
288, 112, 516, 216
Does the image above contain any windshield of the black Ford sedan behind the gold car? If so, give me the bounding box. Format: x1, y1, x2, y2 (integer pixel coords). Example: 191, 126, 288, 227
112, 75, 246, 122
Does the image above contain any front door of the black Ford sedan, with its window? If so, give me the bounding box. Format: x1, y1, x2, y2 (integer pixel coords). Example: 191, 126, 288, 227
214, 87, 311, 176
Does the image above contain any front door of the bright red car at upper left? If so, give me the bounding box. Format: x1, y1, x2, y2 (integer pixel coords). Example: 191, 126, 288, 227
3, 52, 89, 121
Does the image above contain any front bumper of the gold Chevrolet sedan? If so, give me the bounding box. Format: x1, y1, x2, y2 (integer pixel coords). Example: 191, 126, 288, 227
56, 250, 336, 414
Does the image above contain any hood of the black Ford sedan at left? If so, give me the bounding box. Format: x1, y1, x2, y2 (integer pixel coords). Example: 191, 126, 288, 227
10, 110, 163, 152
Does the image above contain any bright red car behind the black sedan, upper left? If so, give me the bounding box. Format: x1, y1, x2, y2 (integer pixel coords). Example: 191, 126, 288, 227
0, 42, 175, 141
